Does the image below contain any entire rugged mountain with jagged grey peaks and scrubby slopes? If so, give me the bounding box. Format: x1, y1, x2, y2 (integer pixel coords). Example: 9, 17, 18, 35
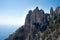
5, 7, 60, 40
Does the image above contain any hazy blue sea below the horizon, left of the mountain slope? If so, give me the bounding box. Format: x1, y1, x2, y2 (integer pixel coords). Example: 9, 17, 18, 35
0, 25, 20, 40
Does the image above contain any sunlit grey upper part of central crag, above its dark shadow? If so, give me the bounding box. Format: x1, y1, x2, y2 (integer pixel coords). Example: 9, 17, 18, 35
25, 7, 44, 25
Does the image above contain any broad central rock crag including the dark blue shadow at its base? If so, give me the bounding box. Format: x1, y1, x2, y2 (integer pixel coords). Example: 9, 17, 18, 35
25, 7, 49, 31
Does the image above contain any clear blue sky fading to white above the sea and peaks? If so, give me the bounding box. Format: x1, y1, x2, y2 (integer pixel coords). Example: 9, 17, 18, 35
0, 0, 60, 25
